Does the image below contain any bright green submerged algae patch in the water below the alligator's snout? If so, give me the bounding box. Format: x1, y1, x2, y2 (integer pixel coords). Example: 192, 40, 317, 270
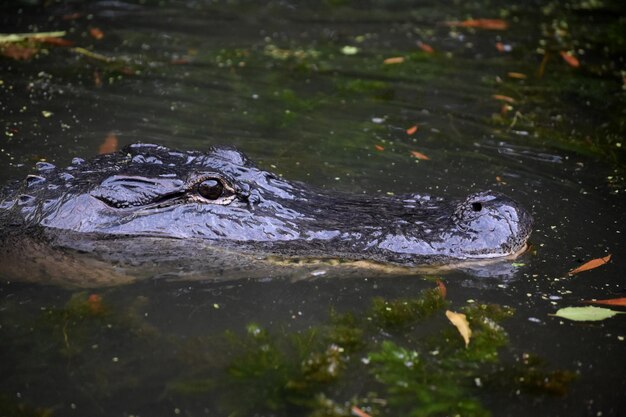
170, 289, 567, 416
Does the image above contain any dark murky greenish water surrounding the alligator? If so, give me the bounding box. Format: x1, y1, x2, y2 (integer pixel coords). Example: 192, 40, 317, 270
0, 0, 626, 416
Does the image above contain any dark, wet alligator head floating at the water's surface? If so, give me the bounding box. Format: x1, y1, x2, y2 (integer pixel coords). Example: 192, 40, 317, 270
0, 143, 532, 286
